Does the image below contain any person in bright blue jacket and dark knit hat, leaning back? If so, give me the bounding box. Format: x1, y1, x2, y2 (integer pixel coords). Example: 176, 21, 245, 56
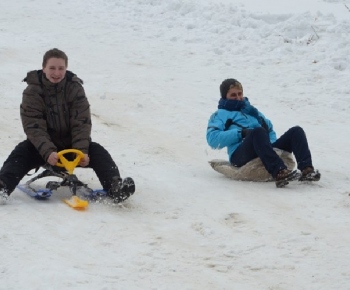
207, 79, 321, 187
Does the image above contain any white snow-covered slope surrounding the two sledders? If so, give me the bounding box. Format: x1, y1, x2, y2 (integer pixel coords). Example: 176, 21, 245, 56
0, 0, 350, 290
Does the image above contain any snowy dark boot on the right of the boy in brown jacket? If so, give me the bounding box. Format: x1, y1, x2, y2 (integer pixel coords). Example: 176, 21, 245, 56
109, 176, 135, 203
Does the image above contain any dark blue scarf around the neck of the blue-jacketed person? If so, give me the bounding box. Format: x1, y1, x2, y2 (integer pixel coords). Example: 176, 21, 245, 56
218, 97, 268, 131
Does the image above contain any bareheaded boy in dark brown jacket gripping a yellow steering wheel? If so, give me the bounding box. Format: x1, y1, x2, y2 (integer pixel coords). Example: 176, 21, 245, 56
0, 48, 135, 203
